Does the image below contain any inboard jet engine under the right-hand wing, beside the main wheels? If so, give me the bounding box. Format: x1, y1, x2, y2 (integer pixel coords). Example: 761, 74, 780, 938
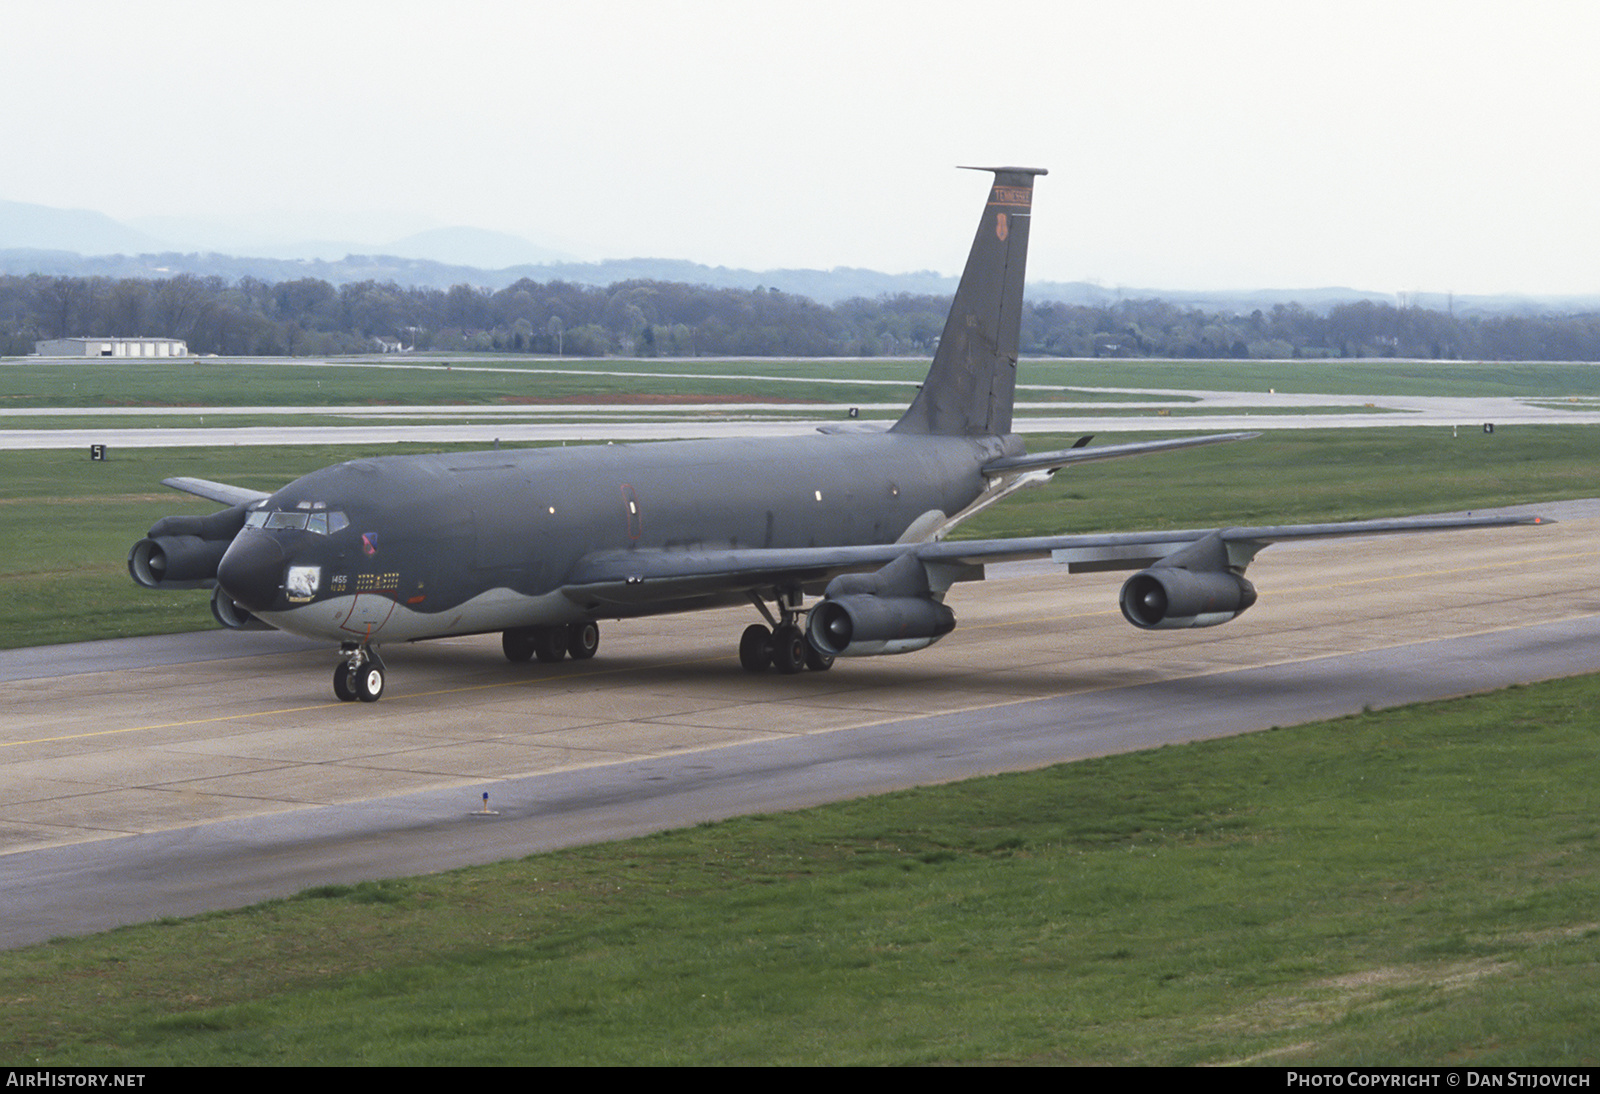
806, 553, 955, 657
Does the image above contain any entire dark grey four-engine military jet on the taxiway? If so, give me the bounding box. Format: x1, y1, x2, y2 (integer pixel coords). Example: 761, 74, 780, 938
128, 166, 1536, 702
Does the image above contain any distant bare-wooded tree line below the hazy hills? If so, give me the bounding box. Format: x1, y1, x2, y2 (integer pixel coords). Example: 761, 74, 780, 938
9, 274, 1600, 361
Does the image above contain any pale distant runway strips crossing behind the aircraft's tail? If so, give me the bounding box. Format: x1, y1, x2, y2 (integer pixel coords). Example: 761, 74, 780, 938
9, 358, 1600, 451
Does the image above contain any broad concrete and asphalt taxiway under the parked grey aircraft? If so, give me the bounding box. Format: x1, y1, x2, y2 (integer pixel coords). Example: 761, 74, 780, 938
0, 502, 1600, 945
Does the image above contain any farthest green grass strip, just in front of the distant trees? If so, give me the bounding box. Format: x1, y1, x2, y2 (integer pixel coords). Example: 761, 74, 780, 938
9, 355, 1600, 409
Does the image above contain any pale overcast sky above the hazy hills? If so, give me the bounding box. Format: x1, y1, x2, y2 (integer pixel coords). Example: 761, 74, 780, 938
0, 0, 1600, 293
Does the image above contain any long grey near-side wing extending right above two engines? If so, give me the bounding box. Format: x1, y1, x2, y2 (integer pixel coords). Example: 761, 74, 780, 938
565, 517, 1554, 605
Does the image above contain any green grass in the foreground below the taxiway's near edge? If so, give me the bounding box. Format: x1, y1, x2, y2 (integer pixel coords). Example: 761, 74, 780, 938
0, 678, 1600, 1067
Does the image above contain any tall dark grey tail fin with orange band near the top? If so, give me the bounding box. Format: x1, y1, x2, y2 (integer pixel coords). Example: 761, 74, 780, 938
891, 168, 1045, 437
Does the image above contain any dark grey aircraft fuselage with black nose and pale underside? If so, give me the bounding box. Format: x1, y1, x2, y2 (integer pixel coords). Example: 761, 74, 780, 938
221, 432, 1022, 641
